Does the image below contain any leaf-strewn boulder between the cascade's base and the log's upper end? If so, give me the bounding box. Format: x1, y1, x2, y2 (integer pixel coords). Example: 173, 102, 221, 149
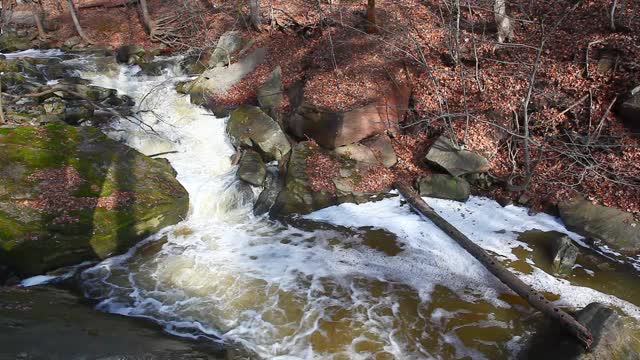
271, 141, 391, 216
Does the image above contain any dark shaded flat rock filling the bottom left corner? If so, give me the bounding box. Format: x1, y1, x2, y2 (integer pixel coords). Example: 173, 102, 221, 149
0, 287, 241, 360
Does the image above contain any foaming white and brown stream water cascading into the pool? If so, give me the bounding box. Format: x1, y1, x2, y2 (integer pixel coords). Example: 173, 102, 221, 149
8, 50, 640, 359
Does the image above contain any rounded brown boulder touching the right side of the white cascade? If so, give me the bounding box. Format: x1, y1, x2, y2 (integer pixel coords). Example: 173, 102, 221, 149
227, 105, 291, 160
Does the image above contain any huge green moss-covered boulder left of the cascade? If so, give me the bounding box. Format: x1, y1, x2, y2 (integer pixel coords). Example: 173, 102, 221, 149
0, 122, 189, 275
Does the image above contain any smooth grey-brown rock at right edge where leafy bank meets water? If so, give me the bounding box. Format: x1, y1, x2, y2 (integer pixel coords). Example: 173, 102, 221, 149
558, 196, 640, 254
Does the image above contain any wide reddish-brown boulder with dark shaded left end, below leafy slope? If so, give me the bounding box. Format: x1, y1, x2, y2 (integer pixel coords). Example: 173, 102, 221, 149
287, 86, 411, 149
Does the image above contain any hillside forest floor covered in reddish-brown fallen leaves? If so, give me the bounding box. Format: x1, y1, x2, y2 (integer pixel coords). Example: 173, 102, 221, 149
20, 0, 640, 217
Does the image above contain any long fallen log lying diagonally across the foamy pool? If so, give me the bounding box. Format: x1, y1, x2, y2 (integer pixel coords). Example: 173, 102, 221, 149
394, 182, 593, 349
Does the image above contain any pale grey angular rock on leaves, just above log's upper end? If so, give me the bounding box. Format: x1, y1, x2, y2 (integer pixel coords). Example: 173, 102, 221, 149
426, 136, 489, 176
